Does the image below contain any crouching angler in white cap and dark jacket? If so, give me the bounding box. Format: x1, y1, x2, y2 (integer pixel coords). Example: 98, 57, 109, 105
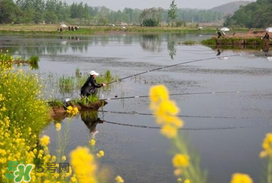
80, 71, 106, 97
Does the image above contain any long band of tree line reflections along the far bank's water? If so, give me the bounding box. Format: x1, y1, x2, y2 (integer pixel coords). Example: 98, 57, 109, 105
0, 33, 212, 59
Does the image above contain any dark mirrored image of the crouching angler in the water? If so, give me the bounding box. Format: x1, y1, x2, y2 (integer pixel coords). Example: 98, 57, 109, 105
81, 111, 104, 135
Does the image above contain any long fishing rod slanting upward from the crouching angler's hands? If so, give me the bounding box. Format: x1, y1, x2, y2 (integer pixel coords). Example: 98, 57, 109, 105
107, 54, 241, 85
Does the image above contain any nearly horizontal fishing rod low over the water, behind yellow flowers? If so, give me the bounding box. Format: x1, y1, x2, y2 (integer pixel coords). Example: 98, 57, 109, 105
100, 91, 245, 101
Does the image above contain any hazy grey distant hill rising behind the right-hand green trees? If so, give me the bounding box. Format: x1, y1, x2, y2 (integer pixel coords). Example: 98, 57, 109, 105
210, 1, 252, 16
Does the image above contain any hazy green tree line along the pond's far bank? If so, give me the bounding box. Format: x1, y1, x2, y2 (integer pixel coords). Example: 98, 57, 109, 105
0, 0, 222, 26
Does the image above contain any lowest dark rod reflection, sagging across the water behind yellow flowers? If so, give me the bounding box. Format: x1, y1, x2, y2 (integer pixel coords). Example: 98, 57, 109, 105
104, 120, 260, 131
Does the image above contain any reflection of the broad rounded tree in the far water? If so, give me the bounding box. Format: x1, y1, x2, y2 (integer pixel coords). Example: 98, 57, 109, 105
140, 34, 162, 52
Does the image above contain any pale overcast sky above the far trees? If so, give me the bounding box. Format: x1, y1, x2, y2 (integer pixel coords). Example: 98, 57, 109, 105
64, 0, 253, 10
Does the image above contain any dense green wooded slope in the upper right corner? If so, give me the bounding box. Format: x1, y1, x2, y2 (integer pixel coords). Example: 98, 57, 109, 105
224, 0, 272, 28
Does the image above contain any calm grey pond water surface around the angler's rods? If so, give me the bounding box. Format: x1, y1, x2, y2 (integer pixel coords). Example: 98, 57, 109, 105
0, 34, 272, 183
